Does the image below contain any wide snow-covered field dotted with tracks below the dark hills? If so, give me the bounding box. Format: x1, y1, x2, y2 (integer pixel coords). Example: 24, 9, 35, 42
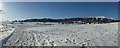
4, 22, 118, 46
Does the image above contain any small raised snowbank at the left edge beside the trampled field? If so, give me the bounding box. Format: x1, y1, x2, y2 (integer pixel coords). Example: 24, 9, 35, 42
0, 23, 15, 46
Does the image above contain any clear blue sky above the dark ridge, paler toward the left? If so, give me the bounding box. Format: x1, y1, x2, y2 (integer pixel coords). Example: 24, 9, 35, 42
3, 2, 118, 20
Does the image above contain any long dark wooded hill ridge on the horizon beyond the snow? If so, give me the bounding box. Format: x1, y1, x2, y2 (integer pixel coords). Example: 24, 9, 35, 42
13, 16, 120, 24
